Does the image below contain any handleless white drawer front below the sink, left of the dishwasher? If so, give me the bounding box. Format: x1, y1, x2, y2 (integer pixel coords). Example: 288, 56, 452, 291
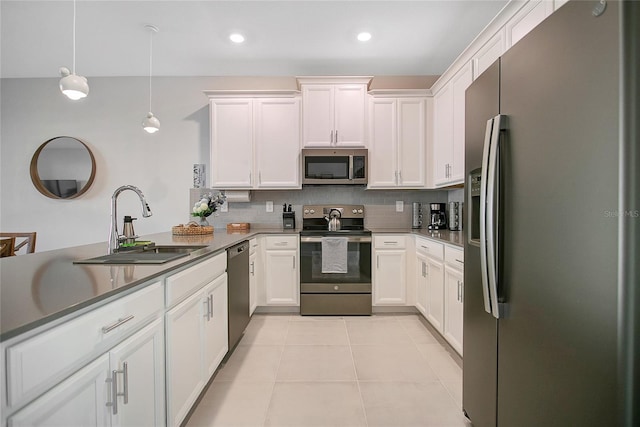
167, 253, 227, 307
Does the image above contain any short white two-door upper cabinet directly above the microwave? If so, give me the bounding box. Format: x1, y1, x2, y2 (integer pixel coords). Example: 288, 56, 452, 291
298, 77, 371, 147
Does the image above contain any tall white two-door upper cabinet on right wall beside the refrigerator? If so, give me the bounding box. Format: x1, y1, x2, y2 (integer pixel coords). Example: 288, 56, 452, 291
433, 62, 472, 187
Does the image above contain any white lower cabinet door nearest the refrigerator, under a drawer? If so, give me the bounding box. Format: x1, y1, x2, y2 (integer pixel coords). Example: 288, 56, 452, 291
444, 267, 464, 355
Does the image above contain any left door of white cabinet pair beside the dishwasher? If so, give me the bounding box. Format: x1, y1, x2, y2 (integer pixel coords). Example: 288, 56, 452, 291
166, 292, 206, 426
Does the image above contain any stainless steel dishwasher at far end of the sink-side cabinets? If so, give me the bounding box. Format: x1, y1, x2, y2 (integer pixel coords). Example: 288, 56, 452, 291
227, 240, 249, 354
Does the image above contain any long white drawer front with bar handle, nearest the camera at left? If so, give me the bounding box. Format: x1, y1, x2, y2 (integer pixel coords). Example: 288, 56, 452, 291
7, 282, 164, 406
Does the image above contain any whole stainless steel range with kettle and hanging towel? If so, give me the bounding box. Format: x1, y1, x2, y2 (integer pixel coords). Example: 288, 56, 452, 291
300, 205, 371, 315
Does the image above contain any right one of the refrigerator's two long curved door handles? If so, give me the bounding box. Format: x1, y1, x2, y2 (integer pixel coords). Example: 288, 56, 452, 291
485, 115, 506, 319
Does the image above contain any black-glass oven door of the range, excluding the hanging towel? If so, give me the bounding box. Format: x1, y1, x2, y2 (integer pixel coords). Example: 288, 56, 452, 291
300, 236, 371, 293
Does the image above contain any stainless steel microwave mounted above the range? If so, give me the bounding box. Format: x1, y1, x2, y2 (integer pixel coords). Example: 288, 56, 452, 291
302, 148, 368, 184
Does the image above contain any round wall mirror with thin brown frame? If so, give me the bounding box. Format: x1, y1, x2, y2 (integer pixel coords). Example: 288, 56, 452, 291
31, 136, 96, 199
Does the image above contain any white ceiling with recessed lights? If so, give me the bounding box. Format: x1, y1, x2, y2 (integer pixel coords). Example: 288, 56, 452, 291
0, 0, 507, 78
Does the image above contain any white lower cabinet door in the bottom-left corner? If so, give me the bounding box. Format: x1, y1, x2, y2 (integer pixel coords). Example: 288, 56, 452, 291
8, 354, 110, 427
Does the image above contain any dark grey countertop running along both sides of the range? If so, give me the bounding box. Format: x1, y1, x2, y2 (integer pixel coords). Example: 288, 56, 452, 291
0, 228, 463, 342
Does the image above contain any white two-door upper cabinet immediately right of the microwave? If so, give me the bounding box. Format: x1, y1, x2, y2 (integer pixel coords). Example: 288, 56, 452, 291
369, 95, 427, 188
